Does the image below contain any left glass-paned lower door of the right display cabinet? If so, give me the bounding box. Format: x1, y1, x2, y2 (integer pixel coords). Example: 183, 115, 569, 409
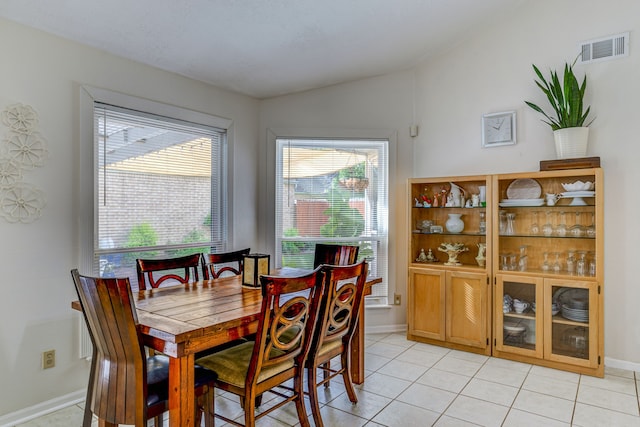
494, 274, 544, 357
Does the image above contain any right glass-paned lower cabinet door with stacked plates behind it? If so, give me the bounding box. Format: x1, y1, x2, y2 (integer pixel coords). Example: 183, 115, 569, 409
545, 279, 598, 367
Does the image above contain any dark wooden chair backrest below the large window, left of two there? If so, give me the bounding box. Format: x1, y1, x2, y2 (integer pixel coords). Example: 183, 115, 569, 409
136, 254, 202, 291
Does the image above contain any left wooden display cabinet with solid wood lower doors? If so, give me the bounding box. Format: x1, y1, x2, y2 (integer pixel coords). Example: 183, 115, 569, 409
407, 175, 492, 354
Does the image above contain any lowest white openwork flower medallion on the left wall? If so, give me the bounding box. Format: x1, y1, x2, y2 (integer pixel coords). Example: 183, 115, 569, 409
0, 183, 46, 224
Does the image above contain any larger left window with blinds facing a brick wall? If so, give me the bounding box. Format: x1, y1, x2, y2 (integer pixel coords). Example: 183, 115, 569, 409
93, 102, 227, 287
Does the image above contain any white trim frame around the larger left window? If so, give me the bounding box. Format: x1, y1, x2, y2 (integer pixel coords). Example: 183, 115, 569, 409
77, 86, 233, 276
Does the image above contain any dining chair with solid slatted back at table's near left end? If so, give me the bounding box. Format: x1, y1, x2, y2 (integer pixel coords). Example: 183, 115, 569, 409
71, 269, 216, 427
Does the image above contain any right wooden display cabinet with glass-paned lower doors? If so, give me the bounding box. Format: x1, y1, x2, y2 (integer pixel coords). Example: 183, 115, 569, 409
492, 168, 604, 377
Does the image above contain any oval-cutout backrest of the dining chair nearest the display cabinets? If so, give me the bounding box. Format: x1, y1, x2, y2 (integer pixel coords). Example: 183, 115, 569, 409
310, 260, 368, 357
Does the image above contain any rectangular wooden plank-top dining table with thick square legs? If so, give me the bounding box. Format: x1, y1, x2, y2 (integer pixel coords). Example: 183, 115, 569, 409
72, 268, 381, 427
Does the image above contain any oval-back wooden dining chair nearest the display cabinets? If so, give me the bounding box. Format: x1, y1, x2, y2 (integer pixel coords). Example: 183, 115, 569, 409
305, 261, 367, 427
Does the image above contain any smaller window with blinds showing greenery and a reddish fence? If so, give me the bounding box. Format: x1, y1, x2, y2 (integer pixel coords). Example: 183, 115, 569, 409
275, 138, 389, 304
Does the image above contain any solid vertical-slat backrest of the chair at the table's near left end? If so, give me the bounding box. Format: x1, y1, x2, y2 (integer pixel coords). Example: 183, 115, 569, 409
71, 270, 147, 424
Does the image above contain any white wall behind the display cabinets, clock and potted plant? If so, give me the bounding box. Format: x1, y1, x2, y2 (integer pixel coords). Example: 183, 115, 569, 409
260, 0, 640, 369
